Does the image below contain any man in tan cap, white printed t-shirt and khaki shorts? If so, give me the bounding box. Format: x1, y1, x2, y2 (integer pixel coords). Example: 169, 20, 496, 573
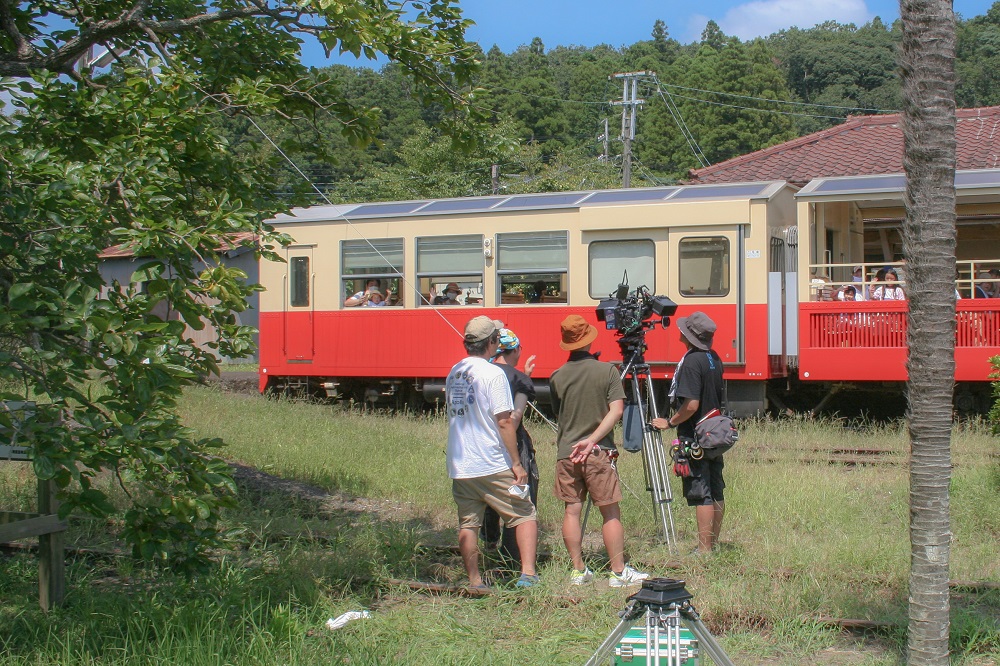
445, 315, 538, 590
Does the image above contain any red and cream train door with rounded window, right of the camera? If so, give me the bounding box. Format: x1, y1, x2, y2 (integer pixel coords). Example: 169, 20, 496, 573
667, 225, 748, 365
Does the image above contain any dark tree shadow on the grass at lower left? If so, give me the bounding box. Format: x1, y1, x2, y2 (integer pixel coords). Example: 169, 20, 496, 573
0, 468, 462, 664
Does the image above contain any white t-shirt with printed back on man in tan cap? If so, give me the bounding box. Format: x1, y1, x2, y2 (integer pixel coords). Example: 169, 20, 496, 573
445, 356, 514, 479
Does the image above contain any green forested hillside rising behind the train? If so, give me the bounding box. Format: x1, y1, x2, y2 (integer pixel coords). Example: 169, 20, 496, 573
228, 2, 1000, 203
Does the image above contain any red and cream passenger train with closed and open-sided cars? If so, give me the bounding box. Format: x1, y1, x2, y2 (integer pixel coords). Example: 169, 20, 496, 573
260, 170, 1000, 414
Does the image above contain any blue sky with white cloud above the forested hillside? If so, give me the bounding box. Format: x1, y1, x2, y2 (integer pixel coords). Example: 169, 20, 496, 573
304, 0, 993, 66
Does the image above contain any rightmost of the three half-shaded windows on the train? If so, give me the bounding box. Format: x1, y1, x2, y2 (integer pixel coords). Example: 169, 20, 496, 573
497, 231, 568, 305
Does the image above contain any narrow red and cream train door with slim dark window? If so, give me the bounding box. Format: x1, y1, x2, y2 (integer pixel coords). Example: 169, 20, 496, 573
282, 245, 316, 363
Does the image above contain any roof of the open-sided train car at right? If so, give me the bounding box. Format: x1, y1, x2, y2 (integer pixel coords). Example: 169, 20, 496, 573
795, 169, 1000, 201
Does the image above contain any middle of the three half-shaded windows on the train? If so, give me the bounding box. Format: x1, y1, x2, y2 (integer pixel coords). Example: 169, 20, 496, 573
417, 235, 485, 305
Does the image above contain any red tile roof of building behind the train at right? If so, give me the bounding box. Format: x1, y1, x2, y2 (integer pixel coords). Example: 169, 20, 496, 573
687, 106, 1000, 187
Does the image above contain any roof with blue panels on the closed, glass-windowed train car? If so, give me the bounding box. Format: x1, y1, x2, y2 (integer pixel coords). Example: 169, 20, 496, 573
272, 180, 788, 224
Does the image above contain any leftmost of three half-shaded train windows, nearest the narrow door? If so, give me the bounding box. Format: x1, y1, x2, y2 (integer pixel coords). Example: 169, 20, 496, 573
340, 238, 403, 305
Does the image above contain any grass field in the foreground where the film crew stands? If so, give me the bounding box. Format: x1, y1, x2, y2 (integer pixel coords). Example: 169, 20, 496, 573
0, 389, 1000, 666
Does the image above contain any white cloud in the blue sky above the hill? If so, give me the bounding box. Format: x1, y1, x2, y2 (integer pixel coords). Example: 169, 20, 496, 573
720, 0, 872, 40
